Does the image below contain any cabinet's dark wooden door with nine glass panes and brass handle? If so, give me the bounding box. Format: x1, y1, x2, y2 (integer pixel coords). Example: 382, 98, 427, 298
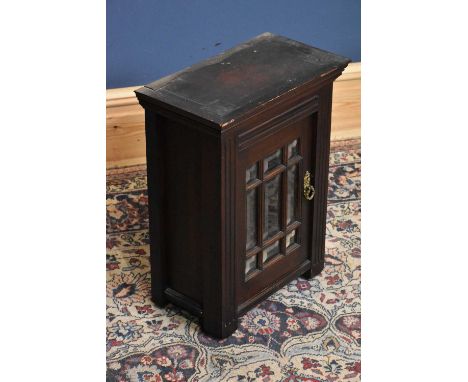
236, 114, 316, 307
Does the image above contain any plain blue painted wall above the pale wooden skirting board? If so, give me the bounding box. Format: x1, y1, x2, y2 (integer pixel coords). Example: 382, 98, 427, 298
107, 0, 361, 88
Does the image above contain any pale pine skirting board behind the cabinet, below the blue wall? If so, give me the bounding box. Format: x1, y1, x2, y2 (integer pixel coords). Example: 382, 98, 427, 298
106, 63, 361, 168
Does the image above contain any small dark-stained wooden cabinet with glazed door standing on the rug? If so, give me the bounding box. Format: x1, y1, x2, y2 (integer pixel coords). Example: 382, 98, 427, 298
136, 33, 349, 338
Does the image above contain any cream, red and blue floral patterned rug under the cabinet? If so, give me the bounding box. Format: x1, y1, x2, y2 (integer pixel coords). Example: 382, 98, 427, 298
106, 140, 361, 382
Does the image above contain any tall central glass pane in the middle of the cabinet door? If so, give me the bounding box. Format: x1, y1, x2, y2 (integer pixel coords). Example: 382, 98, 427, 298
263, 175, 281, 239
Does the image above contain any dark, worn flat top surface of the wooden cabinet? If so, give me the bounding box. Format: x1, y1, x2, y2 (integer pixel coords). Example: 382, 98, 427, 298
136, 33, 350, 127
